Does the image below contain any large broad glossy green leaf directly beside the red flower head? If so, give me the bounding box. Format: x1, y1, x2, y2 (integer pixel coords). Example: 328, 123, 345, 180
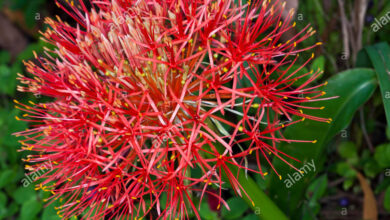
270, 68, 376, 219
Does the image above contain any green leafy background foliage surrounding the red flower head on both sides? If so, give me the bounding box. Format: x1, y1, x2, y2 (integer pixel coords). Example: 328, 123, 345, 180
0, 0, 390, 220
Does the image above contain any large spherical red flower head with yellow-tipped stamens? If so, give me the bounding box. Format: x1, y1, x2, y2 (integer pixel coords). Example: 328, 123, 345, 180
16, 0, 328, 219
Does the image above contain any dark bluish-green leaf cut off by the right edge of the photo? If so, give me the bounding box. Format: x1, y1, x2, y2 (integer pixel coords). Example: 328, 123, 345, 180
366, 43, 390, 125
